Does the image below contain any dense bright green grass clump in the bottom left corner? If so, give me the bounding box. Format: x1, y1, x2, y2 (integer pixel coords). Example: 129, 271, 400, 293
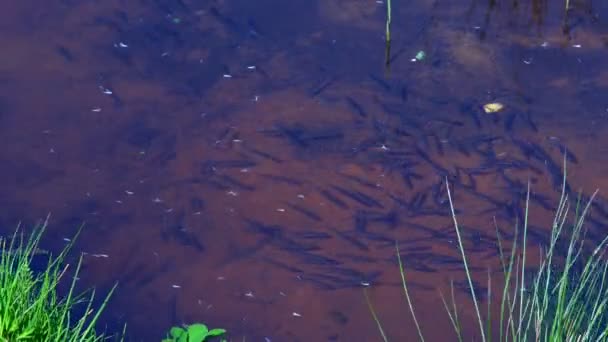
0, 221, 119, 342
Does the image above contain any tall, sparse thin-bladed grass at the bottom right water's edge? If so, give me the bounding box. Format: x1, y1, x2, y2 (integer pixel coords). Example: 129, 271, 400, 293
366, 172, 608, 341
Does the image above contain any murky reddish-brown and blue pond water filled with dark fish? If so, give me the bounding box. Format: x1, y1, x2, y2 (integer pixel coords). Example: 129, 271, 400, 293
0, 0, 608, 341
